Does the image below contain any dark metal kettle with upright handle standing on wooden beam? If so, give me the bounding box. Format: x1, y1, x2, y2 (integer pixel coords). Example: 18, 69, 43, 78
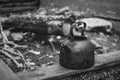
59, 21, 95, 70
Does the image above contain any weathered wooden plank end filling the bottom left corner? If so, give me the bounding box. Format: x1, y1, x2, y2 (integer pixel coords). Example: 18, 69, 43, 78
0, 59, 20, 80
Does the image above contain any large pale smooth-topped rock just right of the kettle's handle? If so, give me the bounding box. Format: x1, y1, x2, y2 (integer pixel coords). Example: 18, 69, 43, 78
80, 18, 113, 32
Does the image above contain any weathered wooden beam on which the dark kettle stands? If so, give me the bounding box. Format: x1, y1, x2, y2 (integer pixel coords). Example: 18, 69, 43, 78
17, 51, 120, 80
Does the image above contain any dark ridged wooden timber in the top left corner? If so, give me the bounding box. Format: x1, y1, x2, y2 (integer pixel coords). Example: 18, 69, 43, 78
0, 0, 40, 13
